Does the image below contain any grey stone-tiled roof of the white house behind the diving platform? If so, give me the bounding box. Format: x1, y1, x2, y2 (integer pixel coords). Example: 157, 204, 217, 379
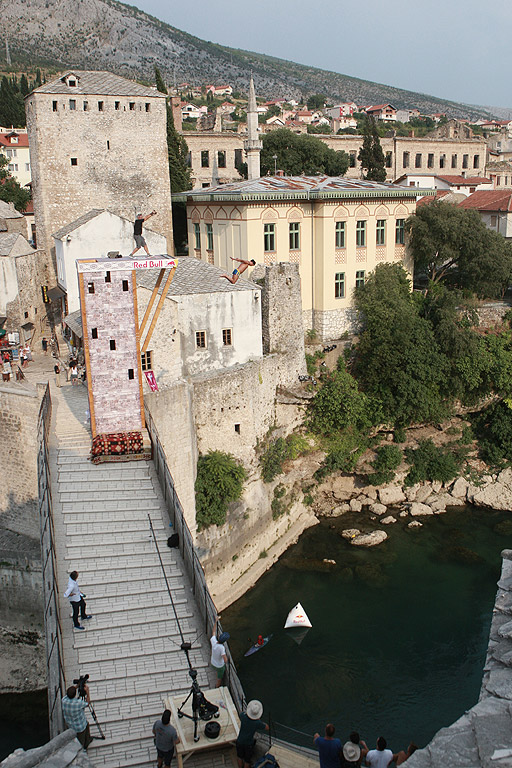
137, 256, 258, 298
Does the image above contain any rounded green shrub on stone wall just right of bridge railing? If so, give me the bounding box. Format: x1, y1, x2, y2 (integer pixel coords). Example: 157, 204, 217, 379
195, 451, 246, 531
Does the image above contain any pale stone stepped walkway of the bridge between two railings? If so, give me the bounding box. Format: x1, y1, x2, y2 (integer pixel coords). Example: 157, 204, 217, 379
50, 385, 233, 768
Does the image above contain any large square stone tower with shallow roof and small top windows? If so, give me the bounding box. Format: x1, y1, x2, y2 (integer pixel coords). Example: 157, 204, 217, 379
26, 70, 173, 254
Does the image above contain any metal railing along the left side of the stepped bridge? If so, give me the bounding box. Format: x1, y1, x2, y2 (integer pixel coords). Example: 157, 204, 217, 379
37, 385, 65, 738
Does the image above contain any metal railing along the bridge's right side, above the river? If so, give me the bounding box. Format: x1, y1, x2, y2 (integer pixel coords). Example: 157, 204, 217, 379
146, 409, 246, 714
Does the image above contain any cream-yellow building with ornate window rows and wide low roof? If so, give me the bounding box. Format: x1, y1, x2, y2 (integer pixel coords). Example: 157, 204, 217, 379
173, 176, 435, 340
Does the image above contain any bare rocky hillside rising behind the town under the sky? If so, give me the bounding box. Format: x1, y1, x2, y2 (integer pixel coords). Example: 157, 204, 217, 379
0, 0, 488, 118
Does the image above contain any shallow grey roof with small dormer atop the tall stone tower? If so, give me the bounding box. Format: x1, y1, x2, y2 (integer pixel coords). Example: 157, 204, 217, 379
32, 69, 165, 99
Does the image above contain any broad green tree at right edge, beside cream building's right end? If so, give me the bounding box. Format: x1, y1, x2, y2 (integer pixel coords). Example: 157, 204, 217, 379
406, 200, 512, 297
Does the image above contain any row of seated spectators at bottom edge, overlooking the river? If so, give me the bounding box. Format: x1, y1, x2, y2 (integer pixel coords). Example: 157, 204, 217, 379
313, 723, 418, 768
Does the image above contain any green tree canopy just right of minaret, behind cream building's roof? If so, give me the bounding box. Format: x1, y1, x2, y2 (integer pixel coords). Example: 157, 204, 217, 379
261, 128, 349, 176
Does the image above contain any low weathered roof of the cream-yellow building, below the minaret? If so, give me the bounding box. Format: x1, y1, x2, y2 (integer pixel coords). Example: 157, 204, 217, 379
173, 176, 432, 200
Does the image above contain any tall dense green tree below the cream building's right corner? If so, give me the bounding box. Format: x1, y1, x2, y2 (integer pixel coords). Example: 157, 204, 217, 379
355, 264, 448, 425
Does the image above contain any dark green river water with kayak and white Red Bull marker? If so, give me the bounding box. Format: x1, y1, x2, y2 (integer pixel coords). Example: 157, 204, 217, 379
222, 508, 512, 751
